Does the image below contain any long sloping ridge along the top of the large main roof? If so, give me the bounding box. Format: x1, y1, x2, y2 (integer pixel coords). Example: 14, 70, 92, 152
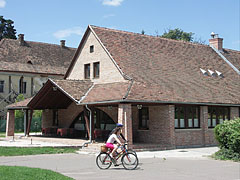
90, 25, 209, 47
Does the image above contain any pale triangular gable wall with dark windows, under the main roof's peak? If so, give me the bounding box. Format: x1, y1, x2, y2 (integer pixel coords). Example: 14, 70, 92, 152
67, 28, 126, 83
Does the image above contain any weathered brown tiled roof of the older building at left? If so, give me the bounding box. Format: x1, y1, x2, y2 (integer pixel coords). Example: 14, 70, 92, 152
0, 39, 76, 75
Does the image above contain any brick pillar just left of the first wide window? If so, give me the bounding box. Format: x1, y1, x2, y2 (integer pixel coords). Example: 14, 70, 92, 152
168, 105, 176, 148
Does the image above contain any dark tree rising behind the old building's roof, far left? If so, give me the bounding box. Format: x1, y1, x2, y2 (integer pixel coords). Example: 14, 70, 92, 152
0, 16, 17, 40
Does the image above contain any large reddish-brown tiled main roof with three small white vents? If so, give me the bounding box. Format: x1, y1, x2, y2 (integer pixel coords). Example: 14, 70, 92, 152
91, 26, 240, 104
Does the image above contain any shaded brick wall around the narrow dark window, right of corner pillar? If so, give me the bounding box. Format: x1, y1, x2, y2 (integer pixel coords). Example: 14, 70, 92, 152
133, 105, 175, 146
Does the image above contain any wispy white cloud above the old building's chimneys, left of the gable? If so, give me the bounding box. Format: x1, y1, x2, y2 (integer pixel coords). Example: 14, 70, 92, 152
53, 27, 84, 39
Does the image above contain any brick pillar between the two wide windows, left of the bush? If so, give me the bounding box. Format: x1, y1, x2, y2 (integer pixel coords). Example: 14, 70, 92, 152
200, 106, 208, 146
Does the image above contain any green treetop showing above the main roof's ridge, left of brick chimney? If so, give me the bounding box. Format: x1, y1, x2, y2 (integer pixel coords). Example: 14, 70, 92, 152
161, 28, 194, 42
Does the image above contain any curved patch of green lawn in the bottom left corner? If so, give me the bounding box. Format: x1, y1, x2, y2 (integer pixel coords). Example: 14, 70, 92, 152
0, 166, 72, 180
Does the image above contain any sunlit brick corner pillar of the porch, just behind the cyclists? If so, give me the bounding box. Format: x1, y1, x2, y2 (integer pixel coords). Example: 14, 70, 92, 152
118, 104, 133, 145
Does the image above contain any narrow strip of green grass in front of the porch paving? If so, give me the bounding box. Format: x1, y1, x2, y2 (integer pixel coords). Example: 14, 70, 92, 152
0, 147, 78, 156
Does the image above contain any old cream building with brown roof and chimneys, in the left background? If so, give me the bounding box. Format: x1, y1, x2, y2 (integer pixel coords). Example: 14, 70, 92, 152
0, 34, 76, 117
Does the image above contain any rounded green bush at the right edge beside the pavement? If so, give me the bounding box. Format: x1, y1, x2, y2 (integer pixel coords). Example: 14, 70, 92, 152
214, 118, 240, 154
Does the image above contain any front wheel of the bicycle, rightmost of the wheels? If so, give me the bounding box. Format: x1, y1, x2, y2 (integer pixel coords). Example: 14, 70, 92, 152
122, 153, 138, 170
